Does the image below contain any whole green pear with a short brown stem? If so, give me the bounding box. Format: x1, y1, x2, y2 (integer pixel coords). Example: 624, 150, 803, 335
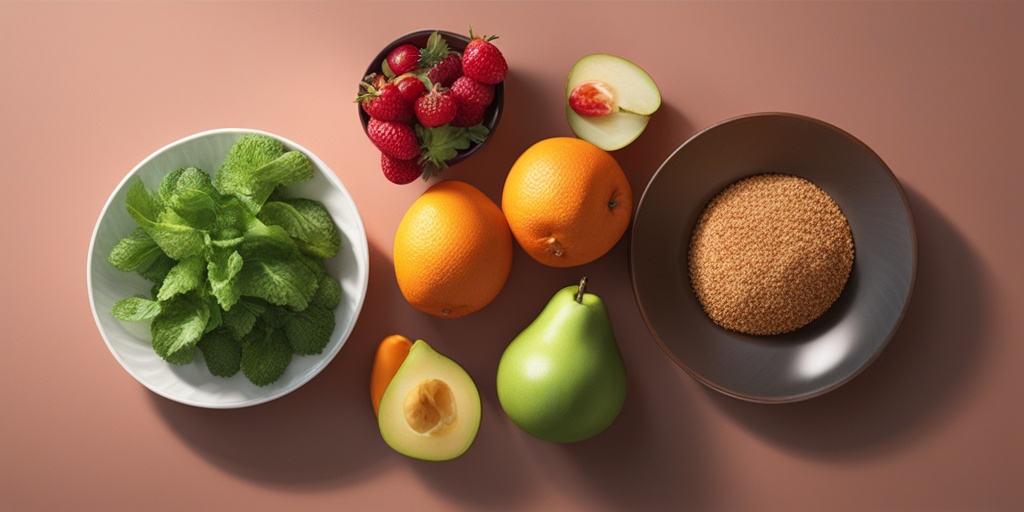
498, 278, 627, 442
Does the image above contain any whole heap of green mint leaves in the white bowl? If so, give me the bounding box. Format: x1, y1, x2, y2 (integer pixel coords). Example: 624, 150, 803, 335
108, 134, 341, 386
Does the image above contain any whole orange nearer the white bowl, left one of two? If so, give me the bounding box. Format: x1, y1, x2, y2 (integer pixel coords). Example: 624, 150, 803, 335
394, 179, 512, 318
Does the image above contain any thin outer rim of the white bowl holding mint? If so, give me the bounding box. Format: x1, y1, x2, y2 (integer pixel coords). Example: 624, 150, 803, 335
85, 128, 370, 409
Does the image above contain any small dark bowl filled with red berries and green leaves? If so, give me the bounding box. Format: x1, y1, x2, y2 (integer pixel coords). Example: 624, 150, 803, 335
355, 29, 508, 184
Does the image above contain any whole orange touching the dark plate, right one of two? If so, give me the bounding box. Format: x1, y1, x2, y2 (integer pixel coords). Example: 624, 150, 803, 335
502, 137, 633, 267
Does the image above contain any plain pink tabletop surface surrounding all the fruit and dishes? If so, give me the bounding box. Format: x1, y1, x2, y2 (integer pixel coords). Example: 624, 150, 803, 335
0, 1, 1024, 511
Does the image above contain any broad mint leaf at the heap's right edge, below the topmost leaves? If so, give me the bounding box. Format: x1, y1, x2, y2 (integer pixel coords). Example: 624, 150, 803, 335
257, 199, 341, 258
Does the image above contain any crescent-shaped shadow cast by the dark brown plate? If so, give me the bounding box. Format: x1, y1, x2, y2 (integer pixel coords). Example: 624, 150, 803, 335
709, 186, 991, 460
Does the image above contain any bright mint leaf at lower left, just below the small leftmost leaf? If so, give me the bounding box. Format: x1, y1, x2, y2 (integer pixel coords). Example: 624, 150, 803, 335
150, 293, 210, 365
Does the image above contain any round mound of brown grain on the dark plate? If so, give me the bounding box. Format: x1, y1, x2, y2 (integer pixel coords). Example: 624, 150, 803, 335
688, 173, 854, 335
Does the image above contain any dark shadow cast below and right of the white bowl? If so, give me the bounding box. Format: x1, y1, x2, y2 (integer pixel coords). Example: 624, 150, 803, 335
152, 239, 401, 487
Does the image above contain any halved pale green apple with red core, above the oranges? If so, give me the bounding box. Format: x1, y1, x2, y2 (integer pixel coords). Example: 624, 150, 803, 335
565, 53, 662, 152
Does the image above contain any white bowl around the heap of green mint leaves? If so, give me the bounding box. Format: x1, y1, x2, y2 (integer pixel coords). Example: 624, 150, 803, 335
87, 129, 370, 409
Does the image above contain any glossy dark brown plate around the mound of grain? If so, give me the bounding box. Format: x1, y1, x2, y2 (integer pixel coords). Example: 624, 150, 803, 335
630, 114, 916, 402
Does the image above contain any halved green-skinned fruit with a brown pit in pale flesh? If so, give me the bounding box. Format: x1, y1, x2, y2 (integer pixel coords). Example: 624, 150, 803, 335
377, 340, 480, 461
